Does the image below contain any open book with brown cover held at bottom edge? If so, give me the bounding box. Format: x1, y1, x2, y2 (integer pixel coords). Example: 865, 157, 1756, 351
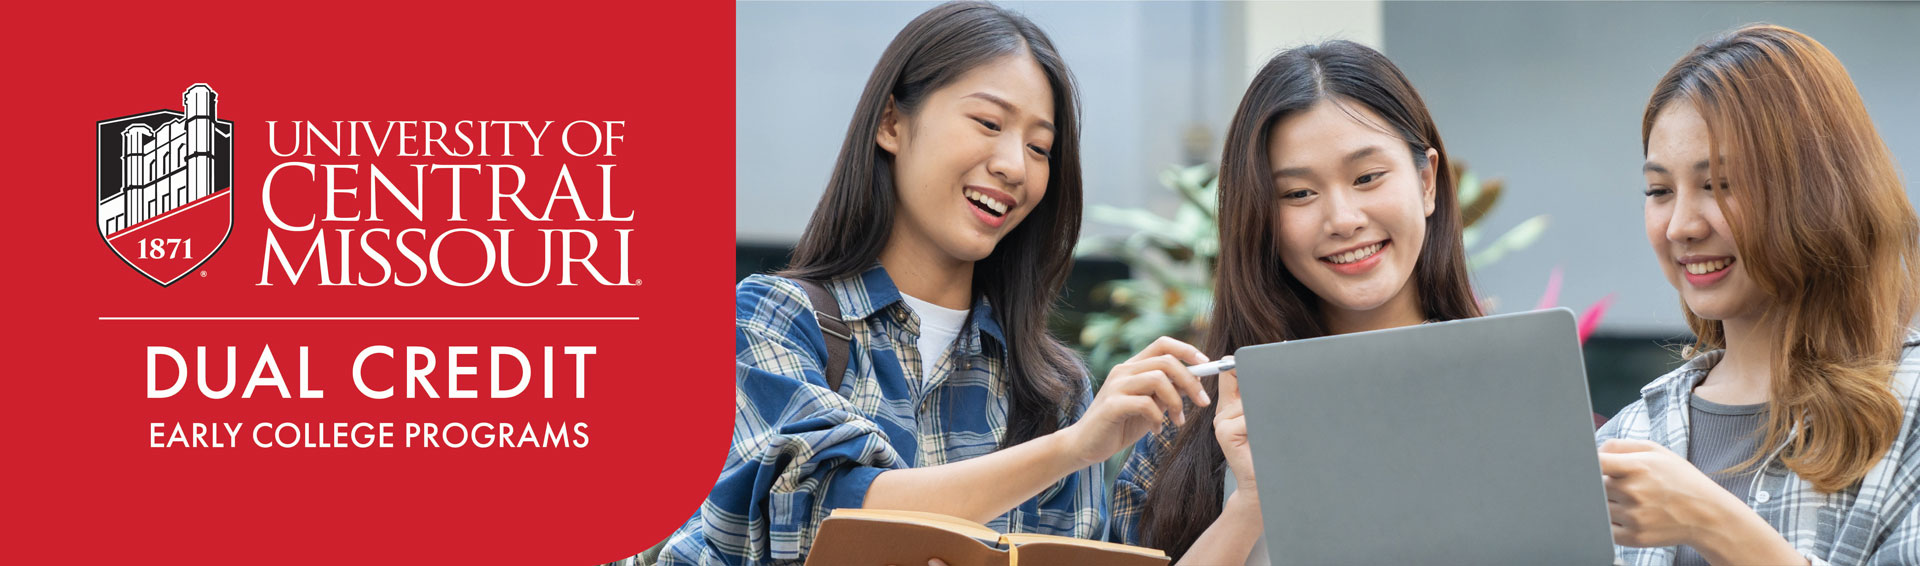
806, 508, 1167, 566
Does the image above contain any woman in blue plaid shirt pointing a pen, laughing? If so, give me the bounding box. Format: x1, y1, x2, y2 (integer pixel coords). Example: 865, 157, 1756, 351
659, 2, 1208, 566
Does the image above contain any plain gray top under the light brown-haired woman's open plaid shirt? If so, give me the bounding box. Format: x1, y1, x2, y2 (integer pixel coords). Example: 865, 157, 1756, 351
1674, 395, 1766, 566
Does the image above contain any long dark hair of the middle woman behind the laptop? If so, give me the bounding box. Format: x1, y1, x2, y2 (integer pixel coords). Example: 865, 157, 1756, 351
1140, 40, 1480, 556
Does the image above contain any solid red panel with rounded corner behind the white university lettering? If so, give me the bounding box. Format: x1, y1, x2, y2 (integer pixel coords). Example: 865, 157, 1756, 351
0, 2, 733, 564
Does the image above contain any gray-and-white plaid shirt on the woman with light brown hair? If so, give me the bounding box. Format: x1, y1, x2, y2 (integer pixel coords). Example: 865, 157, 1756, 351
1594, 332, 1920, 566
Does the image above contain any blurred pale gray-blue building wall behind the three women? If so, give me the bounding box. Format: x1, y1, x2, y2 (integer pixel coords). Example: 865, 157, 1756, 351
735, 2, 1920, 414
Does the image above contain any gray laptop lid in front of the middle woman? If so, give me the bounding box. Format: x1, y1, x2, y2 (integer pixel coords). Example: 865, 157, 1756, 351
1229, 309, 1613, 566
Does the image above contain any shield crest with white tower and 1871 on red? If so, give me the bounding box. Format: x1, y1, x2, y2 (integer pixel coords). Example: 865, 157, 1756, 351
96, 83, 234, 286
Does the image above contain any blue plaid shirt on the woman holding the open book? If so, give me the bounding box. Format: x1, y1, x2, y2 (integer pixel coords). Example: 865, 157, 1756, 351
659, 265, 1108, 564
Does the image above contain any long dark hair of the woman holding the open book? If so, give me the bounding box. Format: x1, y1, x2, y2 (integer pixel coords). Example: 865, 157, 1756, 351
780, 2, 1085, 447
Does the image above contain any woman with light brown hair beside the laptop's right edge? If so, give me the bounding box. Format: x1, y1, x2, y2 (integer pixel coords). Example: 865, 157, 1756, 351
1596, 25, 1920, 564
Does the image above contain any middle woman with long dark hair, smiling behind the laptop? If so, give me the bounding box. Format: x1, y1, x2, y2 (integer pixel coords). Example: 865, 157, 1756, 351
1112, 40, 1480, 564
